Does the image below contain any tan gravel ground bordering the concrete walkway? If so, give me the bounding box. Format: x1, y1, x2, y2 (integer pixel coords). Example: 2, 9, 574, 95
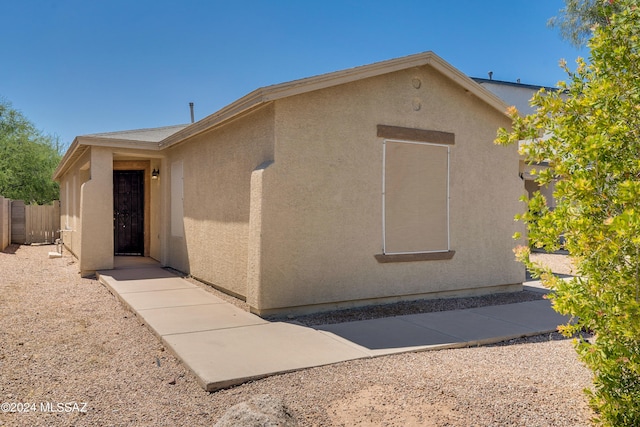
0, 246, 592, 427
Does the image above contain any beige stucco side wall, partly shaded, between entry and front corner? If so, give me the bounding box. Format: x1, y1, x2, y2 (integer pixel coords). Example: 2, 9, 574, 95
164, 105, 274, 296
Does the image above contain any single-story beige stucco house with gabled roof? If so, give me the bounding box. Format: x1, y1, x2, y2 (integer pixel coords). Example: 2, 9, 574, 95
55, 52, 525, 315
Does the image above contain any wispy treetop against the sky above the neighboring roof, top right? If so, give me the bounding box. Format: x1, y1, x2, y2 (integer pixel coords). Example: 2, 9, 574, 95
548, 0, 620, 47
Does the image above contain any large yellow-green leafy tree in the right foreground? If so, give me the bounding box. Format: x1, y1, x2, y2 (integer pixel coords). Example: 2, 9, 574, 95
496, 0, 640, 426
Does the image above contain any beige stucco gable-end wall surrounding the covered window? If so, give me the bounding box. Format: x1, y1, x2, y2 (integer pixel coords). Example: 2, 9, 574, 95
248, 66, 524, 312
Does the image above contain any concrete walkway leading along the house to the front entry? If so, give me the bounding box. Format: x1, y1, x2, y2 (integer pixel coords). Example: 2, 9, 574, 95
98, 262, 566, 391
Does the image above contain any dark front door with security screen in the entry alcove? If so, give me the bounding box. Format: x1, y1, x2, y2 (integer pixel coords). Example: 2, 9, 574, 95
113, 171, 144, 255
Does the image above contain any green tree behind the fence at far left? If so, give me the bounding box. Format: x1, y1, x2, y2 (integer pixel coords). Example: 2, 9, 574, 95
0, 100, 61, 204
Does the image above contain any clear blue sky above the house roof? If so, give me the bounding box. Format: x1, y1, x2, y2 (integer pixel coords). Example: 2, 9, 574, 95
0, 0, 588, 149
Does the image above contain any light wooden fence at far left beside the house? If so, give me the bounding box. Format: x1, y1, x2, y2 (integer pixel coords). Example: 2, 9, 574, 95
0, 197, 60, 250
